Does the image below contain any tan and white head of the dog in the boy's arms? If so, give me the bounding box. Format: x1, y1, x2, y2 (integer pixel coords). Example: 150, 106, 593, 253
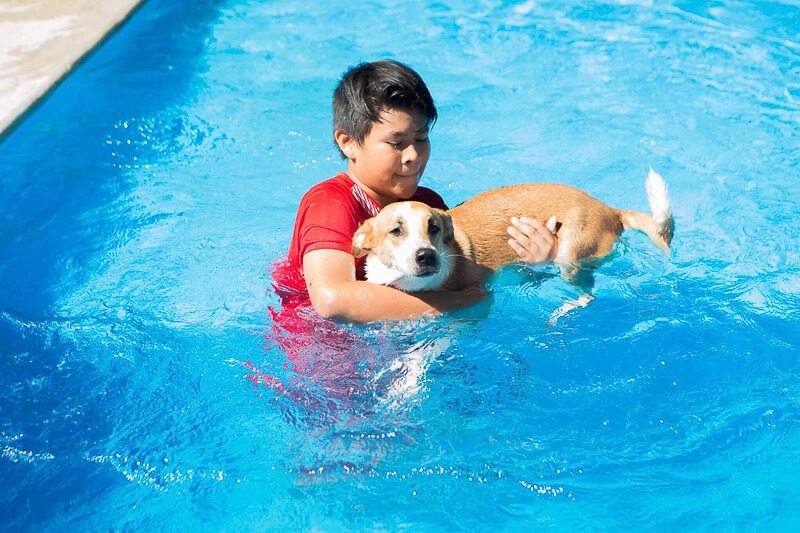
353, 202, 453, 292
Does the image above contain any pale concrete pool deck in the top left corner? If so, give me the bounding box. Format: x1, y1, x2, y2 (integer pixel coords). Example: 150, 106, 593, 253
0, 0, 142, 138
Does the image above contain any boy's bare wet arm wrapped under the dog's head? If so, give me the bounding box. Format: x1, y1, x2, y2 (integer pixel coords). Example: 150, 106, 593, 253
303, 249, 486, 322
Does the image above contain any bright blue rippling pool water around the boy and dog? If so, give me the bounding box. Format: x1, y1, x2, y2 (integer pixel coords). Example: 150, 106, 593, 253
0, 0, 800, 531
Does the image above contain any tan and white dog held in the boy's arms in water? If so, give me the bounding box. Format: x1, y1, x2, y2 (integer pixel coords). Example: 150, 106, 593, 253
353, 169, 674, 295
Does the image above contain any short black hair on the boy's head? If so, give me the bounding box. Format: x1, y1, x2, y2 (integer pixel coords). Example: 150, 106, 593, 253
333, 60, 438, 158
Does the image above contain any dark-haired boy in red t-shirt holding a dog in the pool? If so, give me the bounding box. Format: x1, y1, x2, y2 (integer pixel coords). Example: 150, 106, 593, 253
273, 61, 557, 322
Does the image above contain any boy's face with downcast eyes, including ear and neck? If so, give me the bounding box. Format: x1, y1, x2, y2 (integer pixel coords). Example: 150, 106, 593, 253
340, 110, 431, 207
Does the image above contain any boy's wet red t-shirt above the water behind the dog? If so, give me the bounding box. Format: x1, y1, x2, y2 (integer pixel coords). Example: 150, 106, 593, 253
272, 173, 447, 300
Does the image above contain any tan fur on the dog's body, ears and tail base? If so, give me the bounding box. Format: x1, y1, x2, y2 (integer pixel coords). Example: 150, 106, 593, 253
353, 184, 672, 292
